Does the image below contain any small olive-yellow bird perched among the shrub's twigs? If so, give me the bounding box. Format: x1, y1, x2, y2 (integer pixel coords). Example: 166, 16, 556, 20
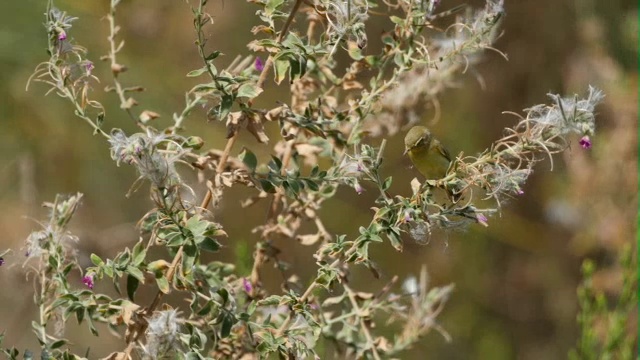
404, 125, 451, 180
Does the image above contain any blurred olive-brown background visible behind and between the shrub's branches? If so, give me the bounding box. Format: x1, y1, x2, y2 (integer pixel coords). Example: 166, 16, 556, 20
0, 0, 638, 359
